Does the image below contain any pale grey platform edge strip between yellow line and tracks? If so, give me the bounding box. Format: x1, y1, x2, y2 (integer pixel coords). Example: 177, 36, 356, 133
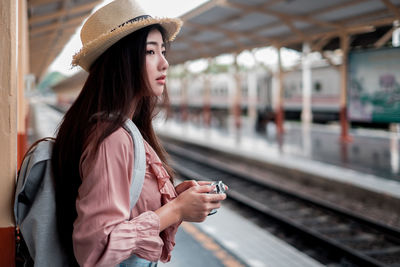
197, 206, 322, 267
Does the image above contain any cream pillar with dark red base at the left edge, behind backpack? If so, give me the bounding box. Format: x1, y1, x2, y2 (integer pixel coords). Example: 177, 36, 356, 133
0, 1, 18, 266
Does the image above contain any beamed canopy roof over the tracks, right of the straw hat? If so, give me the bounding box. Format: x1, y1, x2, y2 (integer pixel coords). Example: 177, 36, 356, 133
169, 0, 400, 64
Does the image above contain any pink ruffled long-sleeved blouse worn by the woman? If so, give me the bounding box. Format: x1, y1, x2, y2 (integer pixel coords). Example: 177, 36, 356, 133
73, 128, 179, 266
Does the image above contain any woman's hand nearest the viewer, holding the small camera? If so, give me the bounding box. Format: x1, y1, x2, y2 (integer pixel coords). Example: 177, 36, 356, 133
173, 182, 226, 222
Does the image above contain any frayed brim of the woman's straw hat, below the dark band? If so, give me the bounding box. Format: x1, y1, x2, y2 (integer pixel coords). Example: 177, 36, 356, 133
72, 18, 182, 72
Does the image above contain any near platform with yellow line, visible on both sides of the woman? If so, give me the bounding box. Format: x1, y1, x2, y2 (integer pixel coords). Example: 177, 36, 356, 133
31, 101, 323, 267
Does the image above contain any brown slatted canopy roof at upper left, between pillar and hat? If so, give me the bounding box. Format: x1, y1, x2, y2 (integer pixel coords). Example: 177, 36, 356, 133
28, 0, 100, 78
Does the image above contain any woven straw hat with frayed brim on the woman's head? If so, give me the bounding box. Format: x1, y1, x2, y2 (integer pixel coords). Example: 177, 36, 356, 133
72, 0, 182, 72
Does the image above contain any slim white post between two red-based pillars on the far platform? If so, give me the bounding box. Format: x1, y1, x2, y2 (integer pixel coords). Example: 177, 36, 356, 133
301, 43, 312, 124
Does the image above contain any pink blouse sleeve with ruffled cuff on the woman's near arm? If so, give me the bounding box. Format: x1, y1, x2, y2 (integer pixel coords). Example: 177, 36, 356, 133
73, 128, 163, 266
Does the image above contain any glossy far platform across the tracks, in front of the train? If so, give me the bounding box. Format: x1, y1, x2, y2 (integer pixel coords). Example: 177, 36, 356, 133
155, 120, 400, 200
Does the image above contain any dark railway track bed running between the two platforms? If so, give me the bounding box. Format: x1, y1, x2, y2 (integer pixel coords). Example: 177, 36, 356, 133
166, 141, 400, 266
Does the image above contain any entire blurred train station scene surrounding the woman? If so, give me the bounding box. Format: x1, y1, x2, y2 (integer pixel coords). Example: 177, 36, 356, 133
0, 0, 400, 267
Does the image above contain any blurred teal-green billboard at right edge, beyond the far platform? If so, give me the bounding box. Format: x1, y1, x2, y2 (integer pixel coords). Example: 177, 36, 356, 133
348, 48, 400, 123
